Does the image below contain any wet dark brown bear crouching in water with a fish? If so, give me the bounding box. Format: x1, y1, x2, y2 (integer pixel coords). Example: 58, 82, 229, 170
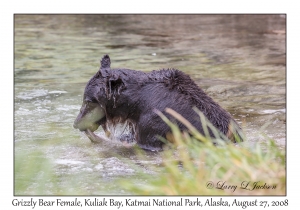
74, 55, 240, 150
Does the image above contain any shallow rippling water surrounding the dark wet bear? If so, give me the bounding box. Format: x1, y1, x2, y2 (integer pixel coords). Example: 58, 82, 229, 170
14, 15, 286, 195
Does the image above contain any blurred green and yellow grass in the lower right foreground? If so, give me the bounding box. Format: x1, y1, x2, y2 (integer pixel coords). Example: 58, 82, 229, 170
123, 110, 286, 195
